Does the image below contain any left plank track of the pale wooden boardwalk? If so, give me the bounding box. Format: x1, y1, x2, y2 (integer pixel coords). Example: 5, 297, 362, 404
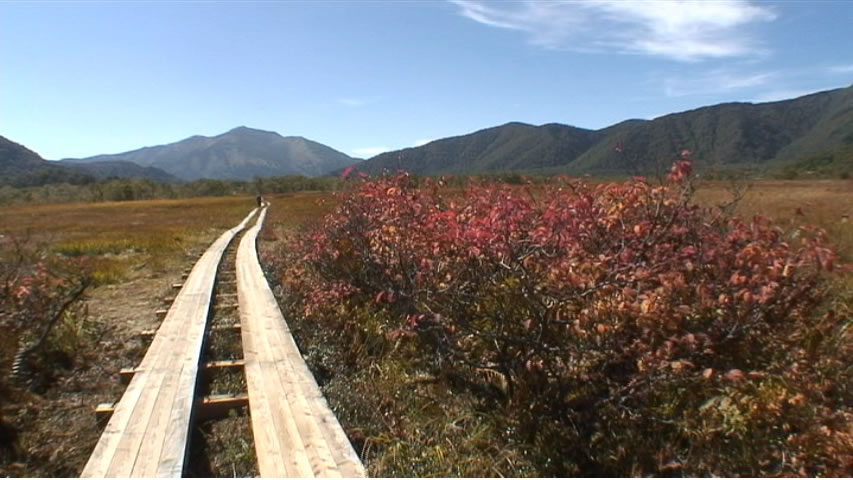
81, 210, 256, 477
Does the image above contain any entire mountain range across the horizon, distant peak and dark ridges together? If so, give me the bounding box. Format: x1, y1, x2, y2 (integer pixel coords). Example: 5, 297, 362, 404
0, 86, 853, 186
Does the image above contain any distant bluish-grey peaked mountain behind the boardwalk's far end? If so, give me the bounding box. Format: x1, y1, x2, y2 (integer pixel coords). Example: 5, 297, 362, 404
63, 127, 358, 180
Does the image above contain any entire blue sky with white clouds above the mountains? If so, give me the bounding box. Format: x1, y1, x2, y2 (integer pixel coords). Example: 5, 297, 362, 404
0, 0, 853, 159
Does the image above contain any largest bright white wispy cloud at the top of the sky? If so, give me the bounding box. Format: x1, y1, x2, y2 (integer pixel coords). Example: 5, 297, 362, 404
450, 0, 776, 61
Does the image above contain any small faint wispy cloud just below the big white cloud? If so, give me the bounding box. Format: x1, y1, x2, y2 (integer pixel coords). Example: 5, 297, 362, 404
663, 69, 779, 97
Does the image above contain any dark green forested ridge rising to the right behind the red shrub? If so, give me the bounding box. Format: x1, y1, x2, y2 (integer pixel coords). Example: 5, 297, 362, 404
357, 86, 853, 175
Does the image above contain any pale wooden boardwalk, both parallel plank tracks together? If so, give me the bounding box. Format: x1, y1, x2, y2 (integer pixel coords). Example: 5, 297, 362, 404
81, 207, 365, 477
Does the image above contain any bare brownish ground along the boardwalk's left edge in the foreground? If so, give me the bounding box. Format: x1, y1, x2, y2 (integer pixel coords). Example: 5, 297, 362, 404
0, 259, 193, 477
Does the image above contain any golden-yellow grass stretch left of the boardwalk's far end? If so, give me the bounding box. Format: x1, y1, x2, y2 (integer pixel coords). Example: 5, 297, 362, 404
0, 197, 253, 285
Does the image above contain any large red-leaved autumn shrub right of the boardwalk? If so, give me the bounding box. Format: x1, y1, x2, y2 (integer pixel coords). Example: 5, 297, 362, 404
281, 159, 853, 476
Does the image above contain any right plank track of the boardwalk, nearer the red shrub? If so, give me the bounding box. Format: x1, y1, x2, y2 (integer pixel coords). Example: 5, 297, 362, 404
236, 209, 365, 477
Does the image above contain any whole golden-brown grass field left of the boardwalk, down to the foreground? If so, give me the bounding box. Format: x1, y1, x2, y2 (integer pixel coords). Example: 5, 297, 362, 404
0, 197, 254, 477
